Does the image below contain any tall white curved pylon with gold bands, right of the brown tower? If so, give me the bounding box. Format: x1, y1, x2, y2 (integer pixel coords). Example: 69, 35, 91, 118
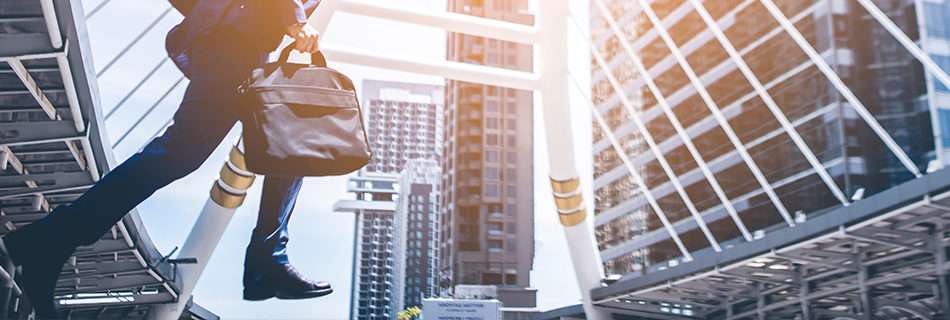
534, 0, 609, 320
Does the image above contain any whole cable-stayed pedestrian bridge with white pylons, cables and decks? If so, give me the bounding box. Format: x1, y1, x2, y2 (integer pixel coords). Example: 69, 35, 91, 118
0, 0, 950, 319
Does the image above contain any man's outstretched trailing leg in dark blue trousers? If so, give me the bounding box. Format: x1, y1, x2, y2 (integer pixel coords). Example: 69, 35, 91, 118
3, 82, 242, 318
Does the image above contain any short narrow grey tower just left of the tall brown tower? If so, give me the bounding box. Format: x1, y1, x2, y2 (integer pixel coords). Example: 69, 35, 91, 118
392, 160, 442, 312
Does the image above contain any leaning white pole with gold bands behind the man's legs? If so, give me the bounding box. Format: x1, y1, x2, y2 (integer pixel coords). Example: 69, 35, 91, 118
148, 146, 255, 320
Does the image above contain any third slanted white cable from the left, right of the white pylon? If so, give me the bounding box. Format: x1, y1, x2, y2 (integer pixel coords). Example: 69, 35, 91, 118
591, 0, 756, 241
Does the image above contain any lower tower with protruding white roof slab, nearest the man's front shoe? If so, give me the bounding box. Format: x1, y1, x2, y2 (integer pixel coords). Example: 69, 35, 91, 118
333, 173, 399, 320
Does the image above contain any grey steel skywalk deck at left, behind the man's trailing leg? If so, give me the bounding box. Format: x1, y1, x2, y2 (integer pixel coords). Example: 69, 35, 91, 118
0, 0, 205, 319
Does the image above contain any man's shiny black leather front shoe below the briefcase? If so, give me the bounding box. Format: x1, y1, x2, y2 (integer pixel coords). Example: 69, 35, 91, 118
244, 264, 333, 301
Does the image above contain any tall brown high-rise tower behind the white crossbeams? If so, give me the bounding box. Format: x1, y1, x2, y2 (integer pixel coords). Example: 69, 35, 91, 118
442, 0, 536, 307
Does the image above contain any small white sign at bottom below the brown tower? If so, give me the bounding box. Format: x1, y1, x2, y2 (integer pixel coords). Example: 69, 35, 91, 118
422, 299, 501, 320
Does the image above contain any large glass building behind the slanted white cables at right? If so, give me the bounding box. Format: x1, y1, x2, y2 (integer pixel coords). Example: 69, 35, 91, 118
591, 0, 950, 274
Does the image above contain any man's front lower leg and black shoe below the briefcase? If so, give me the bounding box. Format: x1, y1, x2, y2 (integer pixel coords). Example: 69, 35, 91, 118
244, 176, 333, 301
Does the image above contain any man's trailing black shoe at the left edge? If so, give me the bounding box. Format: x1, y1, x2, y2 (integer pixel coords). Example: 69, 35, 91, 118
3, 226, 76, 319
